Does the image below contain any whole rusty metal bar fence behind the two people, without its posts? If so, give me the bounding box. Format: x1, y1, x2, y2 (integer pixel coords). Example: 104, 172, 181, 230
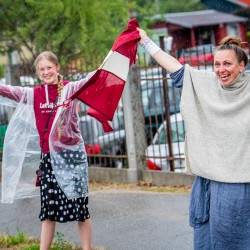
0, 42, 248, 178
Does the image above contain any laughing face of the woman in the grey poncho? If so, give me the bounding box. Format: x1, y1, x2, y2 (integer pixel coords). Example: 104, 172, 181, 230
214, 50, 245, 87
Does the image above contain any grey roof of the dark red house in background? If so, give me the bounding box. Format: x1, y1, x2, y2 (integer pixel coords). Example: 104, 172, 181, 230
153, 10, 247, 28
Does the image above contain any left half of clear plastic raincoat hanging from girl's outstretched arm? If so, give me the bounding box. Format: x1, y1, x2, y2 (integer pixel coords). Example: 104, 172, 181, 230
0, 84, 40, 203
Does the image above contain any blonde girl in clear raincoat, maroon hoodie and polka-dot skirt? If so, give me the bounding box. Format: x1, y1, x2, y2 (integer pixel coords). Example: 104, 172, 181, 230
0, 51, 92, 250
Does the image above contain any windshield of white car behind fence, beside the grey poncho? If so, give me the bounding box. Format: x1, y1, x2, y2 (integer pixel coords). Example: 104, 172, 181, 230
157, 121, 185, 144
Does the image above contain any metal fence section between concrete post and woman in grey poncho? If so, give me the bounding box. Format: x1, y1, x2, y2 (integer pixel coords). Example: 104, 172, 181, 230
140, 61, 185, 172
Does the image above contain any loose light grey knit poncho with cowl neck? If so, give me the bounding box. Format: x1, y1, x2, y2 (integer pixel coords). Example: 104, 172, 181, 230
180, 65, 250, 183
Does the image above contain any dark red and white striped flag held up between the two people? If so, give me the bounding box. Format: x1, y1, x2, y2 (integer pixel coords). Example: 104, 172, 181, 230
70, 18, 140, 132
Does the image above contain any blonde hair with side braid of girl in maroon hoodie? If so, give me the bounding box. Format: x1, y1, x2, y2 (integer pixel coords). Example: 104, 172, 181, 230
34, 51, 64, 98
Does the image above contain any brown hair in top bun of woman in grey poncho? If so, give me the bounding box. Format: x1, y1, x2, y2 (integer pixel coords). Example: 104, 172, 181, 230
215, 36, 248, 66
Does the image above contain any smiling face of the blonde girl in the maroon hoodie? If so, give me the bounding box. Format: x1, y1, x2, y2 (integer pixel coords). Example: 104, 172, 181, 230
37, 58, 60, 84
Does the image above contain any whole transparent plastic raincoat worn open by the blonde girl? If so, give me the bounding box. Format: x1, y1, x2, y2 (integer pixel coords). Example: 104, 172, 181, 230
0, 73, 93, 203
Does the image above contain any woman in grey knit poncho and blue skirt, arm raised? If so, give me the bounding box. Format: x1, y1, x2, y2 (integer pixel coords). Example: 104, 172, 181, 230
138, 29, 250, 250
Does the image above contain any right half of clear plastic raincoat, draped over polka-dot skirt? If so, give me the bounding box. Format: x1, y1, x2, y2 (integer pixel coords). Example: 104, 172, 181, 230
49, 83, 88, 199
